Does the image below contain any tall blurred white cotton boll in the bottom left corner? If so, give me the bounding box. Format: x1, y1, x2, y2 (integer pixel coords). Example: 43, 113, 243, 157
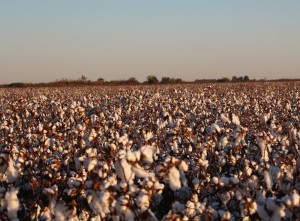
5, 188, 19, 221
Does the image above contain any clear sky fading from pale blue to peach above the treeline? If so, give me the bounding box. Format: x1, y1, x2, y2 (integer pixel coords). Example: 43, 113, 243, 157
0, 0, 300, 84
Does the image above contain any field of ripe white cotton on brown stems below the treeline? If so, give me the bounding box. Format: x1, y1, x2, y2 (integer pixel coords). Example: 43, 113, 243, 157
0, 82, 300, 221
